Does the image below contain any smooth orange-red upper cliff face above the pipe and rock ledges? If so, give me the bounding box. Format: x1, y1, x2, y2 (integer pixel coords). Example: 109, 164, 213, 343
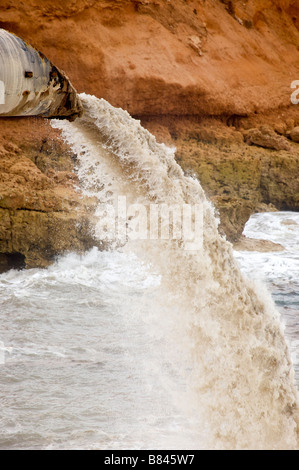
0, 0, 299, 115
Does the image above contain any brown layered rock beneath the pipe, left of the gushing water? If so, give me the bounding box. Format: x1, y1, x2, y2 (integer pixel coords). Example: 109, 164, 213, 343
0, 118, 98, 272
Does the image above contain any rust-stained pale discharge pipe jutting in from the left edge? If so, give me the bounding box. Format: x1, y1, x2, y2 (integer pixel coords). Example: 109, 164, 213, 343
0, 29, 83, 120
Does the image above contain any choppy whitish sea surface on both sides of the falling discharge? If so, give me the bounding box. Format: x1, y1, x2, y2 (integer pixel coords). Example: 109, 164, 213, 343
0, 213, 299, 449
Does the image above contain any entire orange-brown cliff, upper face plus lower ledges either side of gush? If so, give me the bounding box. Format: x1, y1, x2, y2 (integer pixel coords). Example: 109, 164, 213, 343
0, 0, 299, 271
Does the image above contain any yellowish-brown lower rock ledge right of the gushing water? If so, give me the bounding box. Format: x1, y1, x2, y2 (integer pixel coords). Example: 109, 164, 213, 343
144, 116, 299, 242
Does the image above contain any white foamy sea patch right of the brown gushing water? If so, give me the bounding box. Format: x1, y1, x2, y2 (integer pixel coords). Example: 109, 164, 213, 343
235, 212, 299, 388
